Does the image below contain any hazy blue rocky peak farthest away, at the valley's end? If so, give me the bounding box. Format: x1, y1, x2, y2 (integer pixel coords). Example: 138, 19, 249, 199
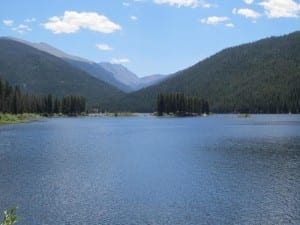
99, 62, 166, 91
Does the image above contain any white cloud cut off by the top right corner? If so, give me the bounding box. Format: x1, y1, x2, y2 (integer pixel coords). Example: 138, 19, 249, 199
259, 0, 300, 18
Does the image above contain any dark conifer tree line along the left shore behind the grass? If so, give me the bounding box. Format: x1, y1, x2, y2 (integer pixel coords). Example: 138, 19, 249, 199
0, 79, 86, 115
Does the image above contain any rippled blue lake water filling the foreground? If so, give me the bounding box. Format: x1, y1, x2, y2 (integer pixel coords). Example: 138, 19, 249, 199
0, 115, 300, 225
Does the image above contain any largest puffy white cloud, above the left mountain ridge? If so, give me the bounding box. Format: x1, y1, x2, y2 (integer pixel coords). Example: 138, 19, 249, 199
43, 11, 122, 34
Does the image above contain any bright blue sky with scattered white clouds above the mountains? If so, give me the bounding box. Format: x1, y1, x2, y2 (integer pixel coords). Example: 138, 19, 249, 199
0, 0, 300, 76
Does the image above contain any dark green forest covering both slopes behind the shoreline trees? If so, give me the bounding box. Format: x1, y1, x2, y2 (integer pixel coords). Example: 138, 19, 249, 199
0, 31, 300, 113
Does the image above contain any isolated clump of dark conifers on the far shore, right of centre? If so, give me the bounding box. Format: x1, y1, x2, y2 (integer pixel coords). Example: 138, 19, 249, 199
157, 93, 209, 116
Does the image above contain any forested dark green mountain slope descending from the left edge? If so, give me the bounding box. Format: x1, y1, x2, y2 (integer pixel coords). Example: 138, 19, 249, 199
0, 38, 123, 107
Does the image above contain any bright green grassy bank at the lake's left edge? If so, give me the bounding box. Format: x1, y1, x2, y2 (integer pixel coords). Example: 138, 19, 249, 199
0, 113, 41, 125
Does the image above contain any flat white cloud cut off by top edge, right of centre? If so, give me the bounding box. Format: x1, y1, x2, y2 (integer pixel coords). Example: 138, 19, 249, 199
153, 0, 215, 8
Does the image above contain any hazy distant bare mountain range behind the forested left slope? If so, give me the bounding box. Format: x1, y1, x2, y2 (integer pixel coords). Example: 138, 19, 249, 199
8, 37, 166, 92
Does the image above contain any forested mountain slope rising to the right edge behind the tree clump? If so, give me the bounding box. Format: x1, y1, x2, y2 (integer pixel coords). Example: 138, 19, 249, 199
118, 32, 300, 113
